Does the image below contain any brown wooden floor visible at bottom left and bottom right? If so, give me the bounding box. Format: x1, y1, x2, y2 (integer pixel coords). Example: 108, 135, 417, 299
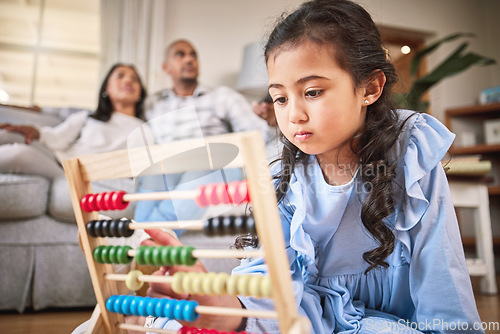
0, 275, 500, 334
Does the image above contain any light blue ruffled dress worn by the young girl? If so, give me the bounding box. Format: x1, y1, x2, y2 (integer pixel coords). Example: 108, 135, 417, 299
234, 111, 483, 334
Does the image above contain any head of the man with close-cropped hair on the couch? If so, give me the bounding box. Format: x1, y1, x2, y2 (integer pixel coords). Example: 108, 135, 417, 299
163, 41, 198, 82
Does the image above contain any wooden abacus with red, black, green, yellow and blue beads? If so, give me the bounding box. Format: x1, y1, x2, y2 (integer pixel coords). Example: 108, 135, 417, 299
63, 132, 310, 334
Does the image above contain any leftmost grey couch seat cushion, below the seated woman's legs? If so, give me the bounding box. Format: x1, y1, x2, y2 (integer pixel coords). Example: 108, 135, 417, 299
0, 174, 49, 221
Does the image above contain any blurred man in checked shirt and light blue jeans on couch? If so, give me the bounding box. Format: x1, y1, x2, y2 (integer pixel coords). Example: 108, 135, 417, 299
135, 40, 276, 226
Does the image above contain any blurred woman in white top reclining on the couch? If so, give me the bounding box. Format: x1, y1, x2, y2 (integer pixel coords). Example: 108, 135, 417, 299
0, 64, 147, 178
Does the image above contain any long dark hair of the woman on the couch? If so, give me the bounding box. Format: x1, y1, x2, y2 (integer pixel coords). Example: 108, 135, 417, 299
90, 63, 147, 122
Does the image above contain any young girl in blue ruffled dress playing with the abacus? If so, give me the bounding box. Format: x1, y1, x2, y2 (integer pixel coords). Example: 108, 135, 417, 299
143, 0, 482, 334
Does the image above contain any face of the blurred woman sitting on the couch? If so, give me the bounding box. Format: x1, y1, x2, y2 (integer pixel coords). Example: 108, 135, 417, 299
106, 66, 141, 109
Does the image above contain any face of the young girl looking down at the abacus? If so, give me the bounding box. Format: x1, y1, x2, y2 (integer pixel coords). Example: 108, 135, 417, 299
267, 41, 366, 164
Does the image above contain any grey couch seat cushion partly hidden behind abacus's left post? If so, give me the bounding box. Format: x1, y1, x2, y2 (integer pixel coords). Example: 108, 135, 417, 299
48, 176, 135, 223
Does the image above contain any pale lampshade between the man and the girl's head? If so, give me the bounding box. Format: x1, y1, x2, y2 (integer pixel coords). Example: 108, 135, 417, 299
237, 42, 268, 99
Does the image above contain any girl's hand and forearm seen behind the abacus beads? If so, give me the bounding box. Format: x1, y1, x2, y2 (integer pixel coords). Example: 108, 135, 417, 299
142, 230, 242, 331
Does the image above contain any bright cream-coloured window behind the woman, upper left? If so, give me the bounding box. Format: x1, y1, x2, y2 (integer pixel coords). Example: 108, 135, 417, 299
0, 0, 100, 109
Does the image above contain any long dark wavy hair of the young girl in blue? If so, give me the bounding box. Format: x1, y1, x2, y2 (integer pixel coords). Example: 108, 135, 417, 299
237, 0, 402, 272
